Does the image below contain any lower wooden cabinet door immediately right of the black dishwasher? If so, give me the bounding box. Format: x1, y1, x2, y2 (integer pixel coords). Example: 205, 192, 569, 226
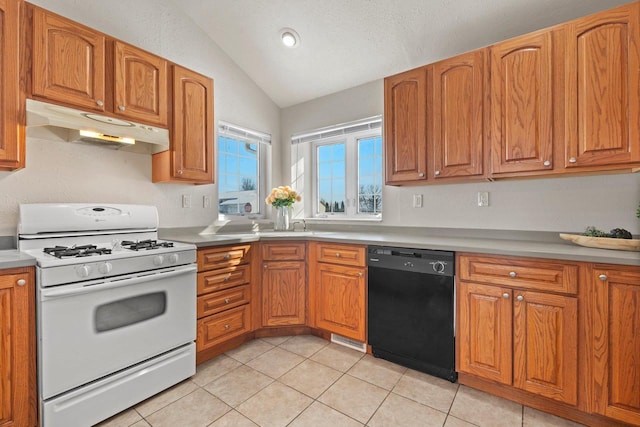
457, 282, 512, 385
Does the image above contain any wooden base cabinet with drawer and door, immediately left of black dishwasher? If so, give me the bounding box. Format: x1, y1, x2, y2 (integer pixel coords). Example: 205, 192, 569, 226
309, 242, 367, 342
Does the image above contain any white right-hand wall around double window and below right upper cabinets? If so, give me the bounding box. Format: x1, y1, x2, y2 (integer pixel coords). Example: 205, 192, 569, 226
281, 80, 640, 234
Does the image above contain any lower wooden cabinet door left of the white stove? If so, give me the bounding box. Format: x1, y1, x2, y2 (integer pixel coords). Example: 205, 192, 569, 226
0, 270, 36, 427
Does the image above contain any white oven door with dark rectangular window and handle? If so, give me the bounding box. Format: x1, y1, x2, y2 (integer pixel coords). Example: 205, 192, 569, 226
38, 265, 196, 399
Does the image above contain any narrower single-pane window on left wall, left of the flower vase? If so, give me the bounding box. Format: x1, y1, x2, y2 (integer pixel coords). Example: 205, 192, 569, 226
218, 122, 271, 216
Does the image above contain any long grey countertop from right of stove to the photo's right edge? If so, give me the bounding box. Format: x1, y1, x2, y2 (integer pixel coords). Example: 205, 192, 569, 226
160, 226, 640, 266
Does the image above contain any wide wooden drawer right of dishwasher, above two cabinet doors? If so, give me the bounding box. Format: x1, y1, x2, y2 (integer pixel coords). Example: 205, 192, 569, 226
458, 255, 578, 294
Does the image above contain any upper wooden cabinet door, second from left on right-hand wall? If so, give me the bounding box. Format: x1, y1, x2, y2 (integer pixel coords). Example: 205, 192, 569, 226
429, 50, 485, 179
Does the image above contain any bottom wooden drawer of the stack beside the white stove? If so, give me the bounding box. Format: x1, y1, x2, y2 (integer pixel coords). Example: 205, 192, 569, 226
196, 305, 251, 351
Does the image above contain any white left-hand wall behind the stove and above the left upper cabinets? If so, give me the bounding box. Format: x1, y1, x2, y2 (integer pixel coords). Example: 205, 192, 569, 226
0, 0, 280, 235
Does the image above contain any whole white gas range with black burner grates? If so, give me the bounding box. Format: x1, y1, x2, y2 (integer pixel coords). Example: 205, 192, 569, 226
18, 204, 197, 427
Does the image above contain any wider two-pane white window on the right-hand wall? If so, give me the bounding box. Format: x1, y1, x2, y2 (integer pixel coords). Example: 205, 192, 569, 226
292, 117, 383, 218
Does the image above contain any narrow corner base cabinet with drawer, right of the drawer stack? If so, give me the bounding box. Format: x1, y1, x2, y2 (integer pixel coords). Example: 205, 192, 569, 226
261, 242, 307, 326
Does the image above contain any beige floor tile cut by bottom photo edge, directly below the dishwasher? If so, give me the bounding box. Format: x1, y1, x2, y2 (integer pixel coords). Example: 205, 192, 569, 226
367, 393, 447, 427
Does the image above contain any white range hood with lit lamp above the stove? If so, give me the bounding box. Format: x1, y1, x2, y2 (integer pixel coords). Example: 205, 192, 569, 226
27, 99, 169, 154
